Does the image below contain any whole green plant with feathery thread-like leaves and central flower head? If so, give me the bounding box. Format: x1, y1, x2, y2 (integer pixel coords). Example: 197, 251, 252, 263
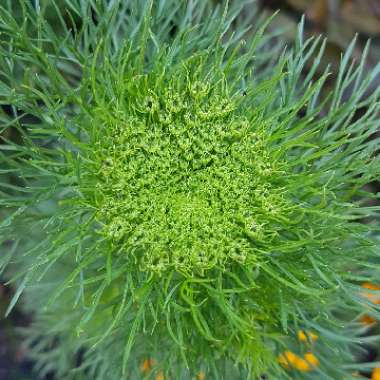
0, 0, 380, 379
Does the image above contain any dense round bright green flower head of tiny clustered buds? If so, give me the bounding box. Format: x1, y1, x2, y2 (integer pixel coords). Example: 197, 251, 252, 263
91, 75, 284, 275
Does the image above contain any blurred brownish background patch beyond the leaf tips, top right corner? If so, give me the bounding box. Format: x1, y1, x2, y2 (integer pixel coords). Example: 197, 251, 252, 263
259, 0, 380, 85
